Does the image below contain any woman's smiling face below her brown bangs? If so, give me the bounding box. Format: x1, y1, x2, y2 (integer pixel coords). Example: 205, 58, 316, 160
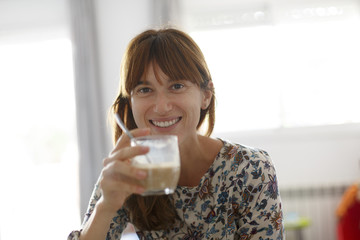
131, 64, 211, 143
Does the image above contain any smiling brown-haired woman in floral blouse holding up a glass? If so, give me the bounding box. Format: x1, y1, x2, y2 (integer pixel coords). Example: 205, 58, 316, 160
69, 28, 283, 240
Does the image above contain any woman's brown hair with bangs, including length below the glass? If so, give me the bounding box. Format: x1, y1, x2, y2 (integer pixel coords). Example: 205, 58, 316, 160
112, 28, 215, 230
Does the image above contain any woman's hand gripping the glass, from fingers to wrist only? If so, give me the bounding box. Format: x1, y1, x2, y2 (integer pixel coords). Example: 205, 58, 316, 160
98, 128, 150, 213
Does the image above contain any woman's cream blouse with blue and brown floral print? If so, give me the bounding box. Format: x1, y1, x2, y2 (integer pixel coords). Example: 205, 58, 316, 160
68, 140, 285, 240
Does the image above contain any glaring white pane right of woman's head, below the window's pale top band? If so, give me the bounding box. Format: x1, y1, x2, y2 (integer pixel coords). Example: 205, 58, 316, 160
191, 19, 360, 132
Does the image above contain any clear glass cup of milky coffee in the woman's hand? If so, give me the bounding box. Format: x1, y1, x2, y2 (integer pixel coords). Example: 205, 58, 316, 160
131, 135, 180, 196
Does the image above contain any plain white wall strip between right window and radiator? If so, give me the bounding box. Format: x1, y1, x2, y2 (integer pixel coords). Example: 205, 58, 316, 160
216, 124, 360, 187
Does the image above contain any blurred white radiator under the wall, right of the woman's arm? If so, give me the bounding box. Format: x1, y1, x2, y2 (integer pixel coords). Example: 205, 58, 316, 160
280, 184, 349, 240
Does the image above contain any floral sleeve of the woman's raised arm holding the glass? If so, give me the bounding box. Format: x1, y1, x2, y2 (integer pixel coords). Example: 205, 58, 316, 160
68, 175, 128, 240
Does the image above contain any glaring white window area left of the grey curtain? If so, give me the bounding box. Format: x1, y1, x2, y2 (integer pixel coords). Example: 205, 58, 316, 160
0, 39, 80, 240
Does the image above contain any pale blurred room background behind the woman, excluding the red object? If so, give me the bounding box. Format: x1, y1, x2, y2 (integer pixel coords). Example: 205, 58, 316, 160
0, 0, 360, 240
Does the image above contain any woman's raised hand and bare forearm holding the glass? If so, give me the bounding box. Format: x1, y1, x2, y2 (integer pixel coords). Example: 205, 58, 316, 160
80, 128, 150, 240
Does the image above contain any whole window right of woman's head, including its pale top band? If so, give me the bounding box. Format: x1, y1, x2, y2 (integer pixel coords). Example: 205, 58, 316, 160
183, 0, 360, 132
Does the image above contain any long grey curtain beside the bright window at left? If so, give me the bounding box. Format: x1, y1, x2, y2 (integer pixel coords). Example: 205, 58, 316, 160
69, 0, 108, 216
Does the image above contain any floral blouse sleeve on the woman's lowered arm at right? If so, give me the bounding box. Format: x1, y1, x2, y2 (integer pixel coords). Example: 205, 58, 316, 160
237, 148, 284, 240
